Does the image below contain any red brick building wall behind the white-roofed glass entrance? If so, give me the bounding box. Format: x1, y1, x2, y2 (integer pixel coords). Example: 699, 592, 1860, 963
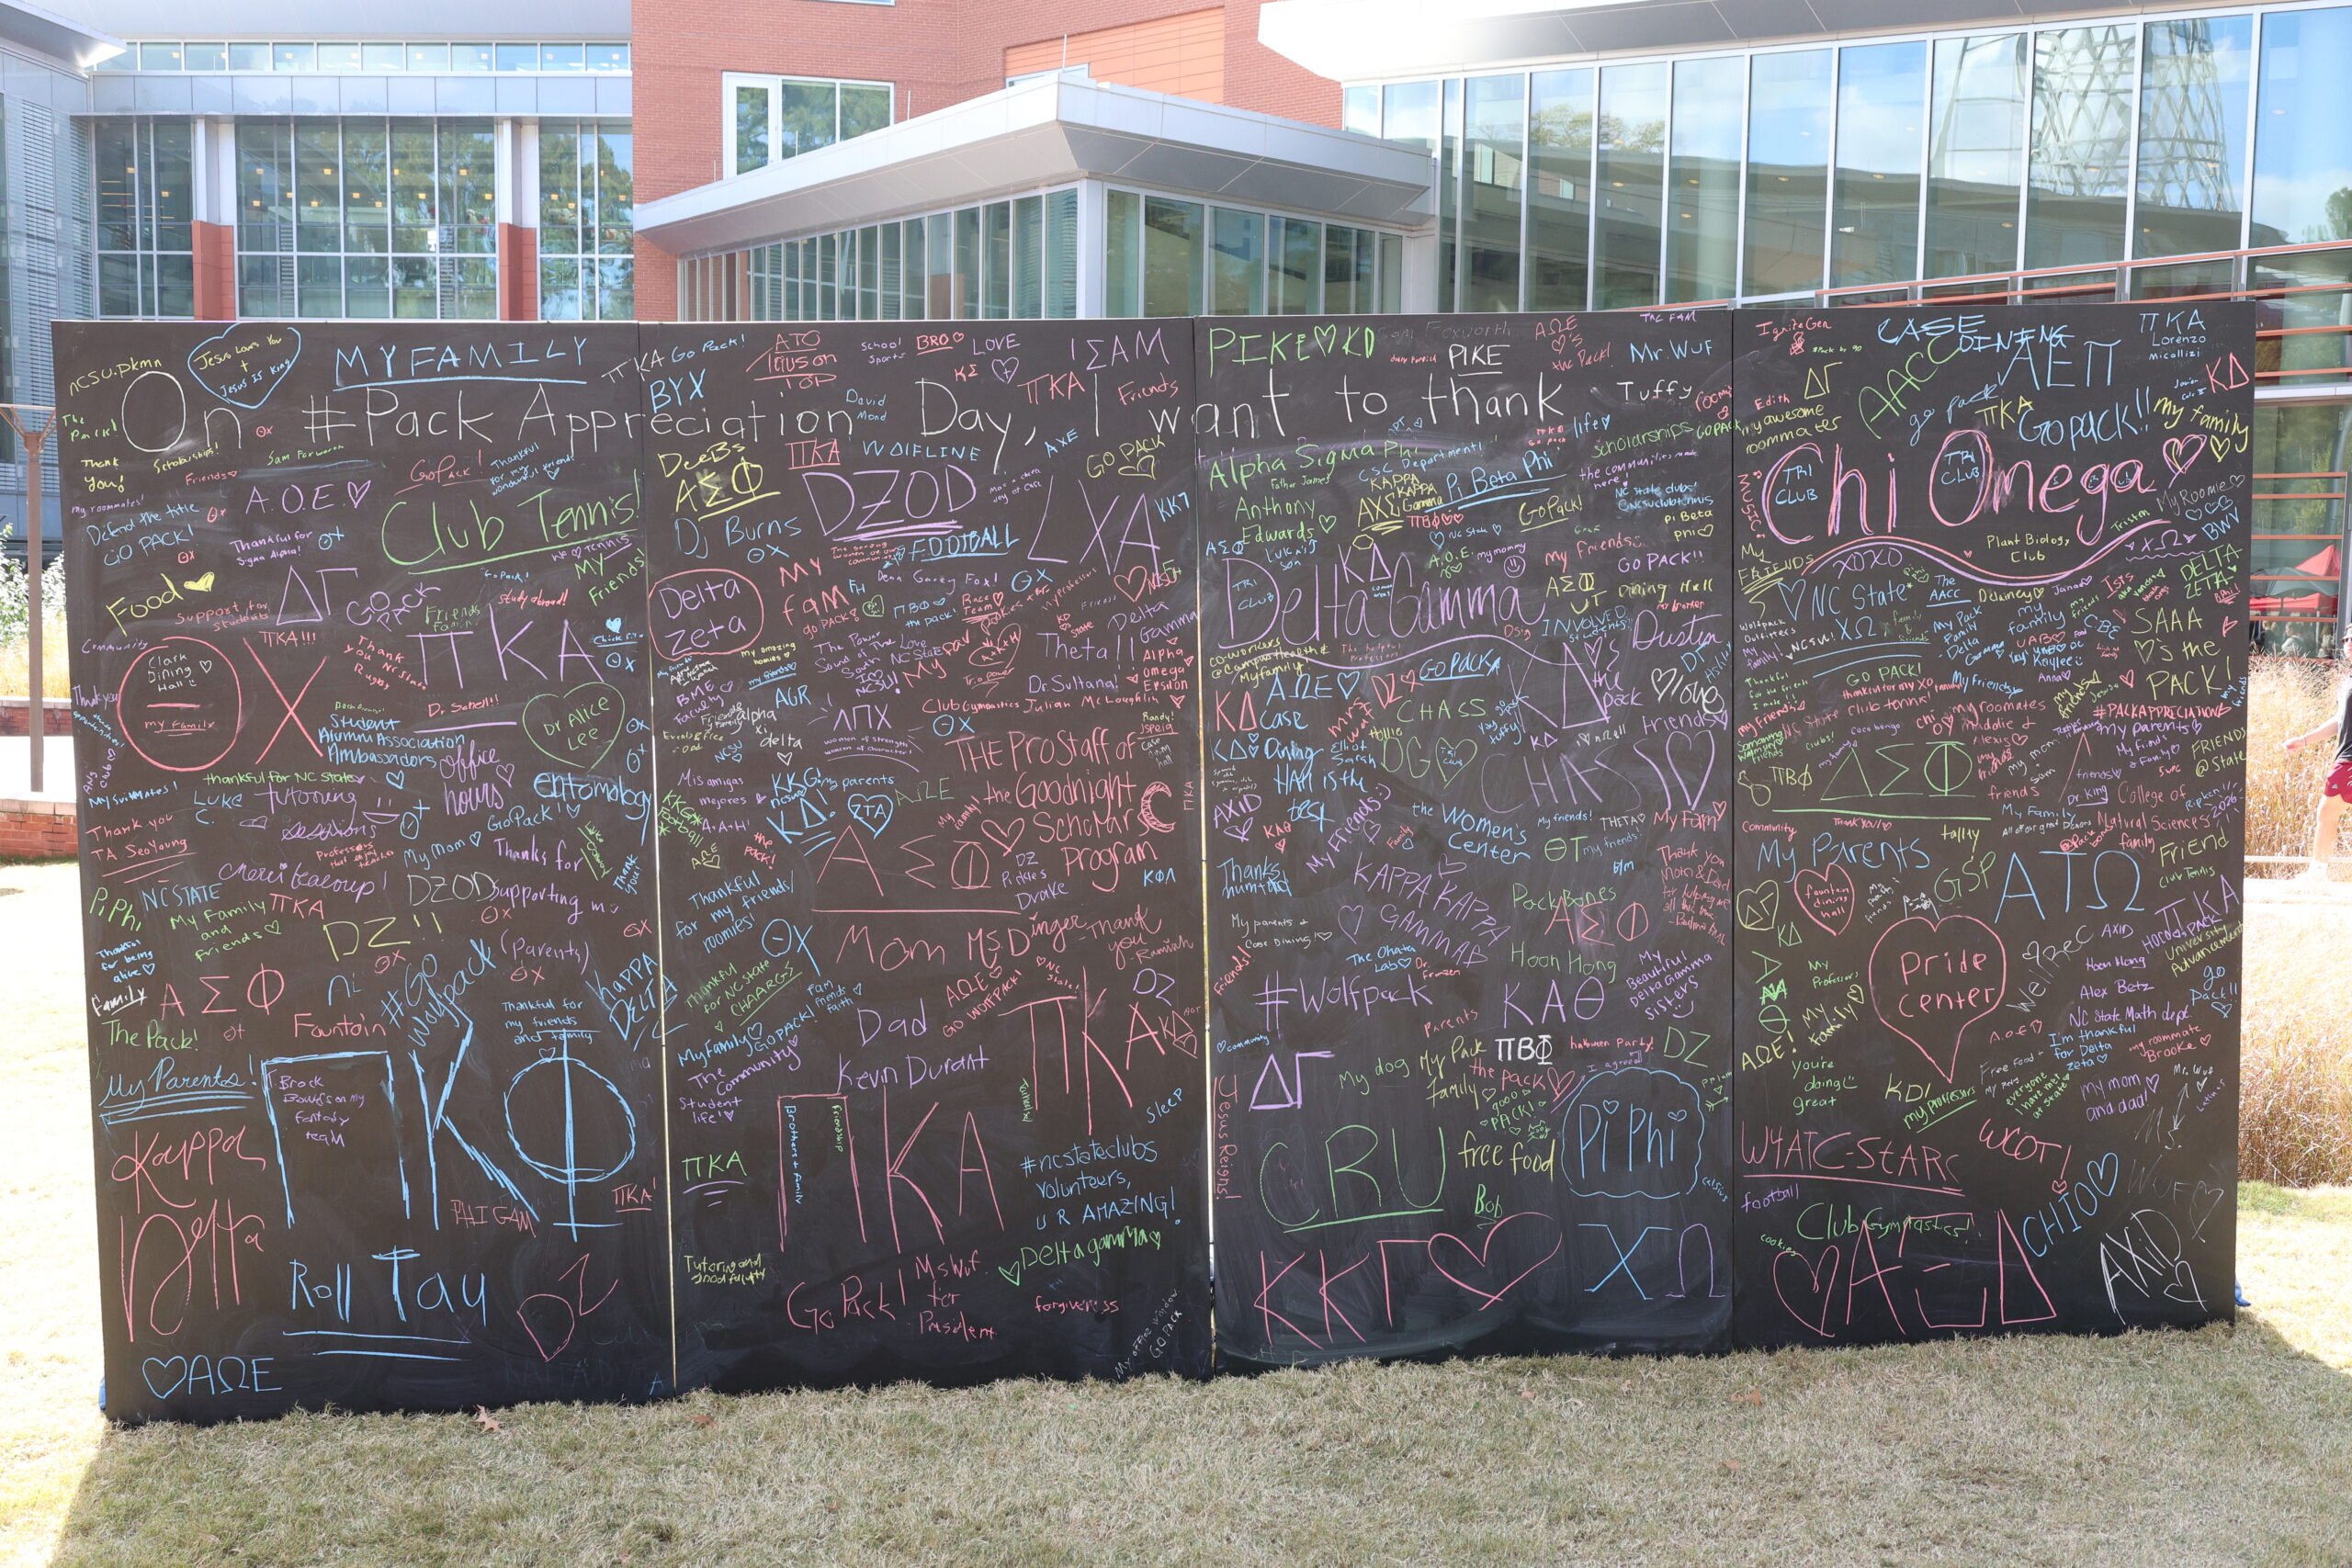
633, 0, 1340, 320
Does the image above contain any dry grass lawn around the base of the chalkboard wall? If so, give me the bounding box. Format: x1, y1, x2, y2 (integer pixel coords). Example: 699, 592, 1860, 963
0, 865, 2352, 1568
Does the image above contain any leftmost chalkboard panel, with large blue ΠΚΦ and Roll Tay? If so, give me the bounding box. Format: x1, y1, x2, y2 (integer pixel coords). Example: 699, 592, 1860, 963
56, 322, 673, 1420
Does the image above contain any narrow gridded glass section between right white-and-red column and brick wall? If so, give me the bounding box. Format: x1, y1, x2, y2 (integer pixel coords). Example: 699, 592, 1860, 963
538, 120, 638, 322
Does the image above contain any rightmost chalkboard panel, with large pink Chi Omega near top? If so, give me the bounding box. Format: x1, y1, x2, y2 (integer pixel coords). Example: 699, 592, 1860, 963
1736, 303, 2253, 1345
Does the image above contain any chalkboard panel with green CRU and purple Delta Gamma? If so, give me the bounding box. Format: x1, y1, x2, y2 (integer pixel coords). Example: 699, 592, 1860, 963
1194, 312, 1734, 1363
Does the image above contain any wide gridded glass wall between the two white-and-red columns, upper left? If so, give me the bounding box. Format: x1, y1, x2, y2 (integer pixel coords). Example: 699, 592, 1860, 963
238, 118, 499, 320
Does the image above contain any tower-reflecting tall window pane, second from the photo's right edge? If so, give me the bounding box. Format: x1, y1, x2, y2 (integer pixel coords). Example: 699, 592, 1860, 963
2131, 17, 2253, 256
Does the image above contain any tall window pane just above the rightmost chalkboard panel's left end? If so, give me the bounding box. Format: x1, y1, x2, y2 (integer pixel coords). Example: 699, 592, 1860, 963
1740, 50, 1830, 294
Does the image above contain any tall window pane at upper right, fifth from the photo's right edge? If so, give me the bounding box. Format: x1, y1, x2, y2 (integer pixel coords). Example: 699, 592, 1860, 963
1830, 45, 1927, 285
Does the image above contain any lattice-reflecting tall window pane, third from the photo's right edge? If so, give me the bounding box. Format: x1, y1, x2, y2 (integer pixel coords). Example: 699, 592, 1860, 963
2025, 28, 2138, 268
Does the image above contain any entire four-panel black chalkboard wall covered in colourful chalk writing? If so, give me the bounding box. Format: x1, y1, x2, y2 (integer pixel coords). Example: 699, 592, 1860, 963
56, 306, 2251, 1420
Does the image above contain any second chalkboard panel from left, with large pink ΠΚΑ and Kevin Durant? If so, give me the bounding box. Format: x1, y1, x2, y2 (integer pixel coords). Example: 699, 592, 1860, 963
639, 322, 1209, 1389
